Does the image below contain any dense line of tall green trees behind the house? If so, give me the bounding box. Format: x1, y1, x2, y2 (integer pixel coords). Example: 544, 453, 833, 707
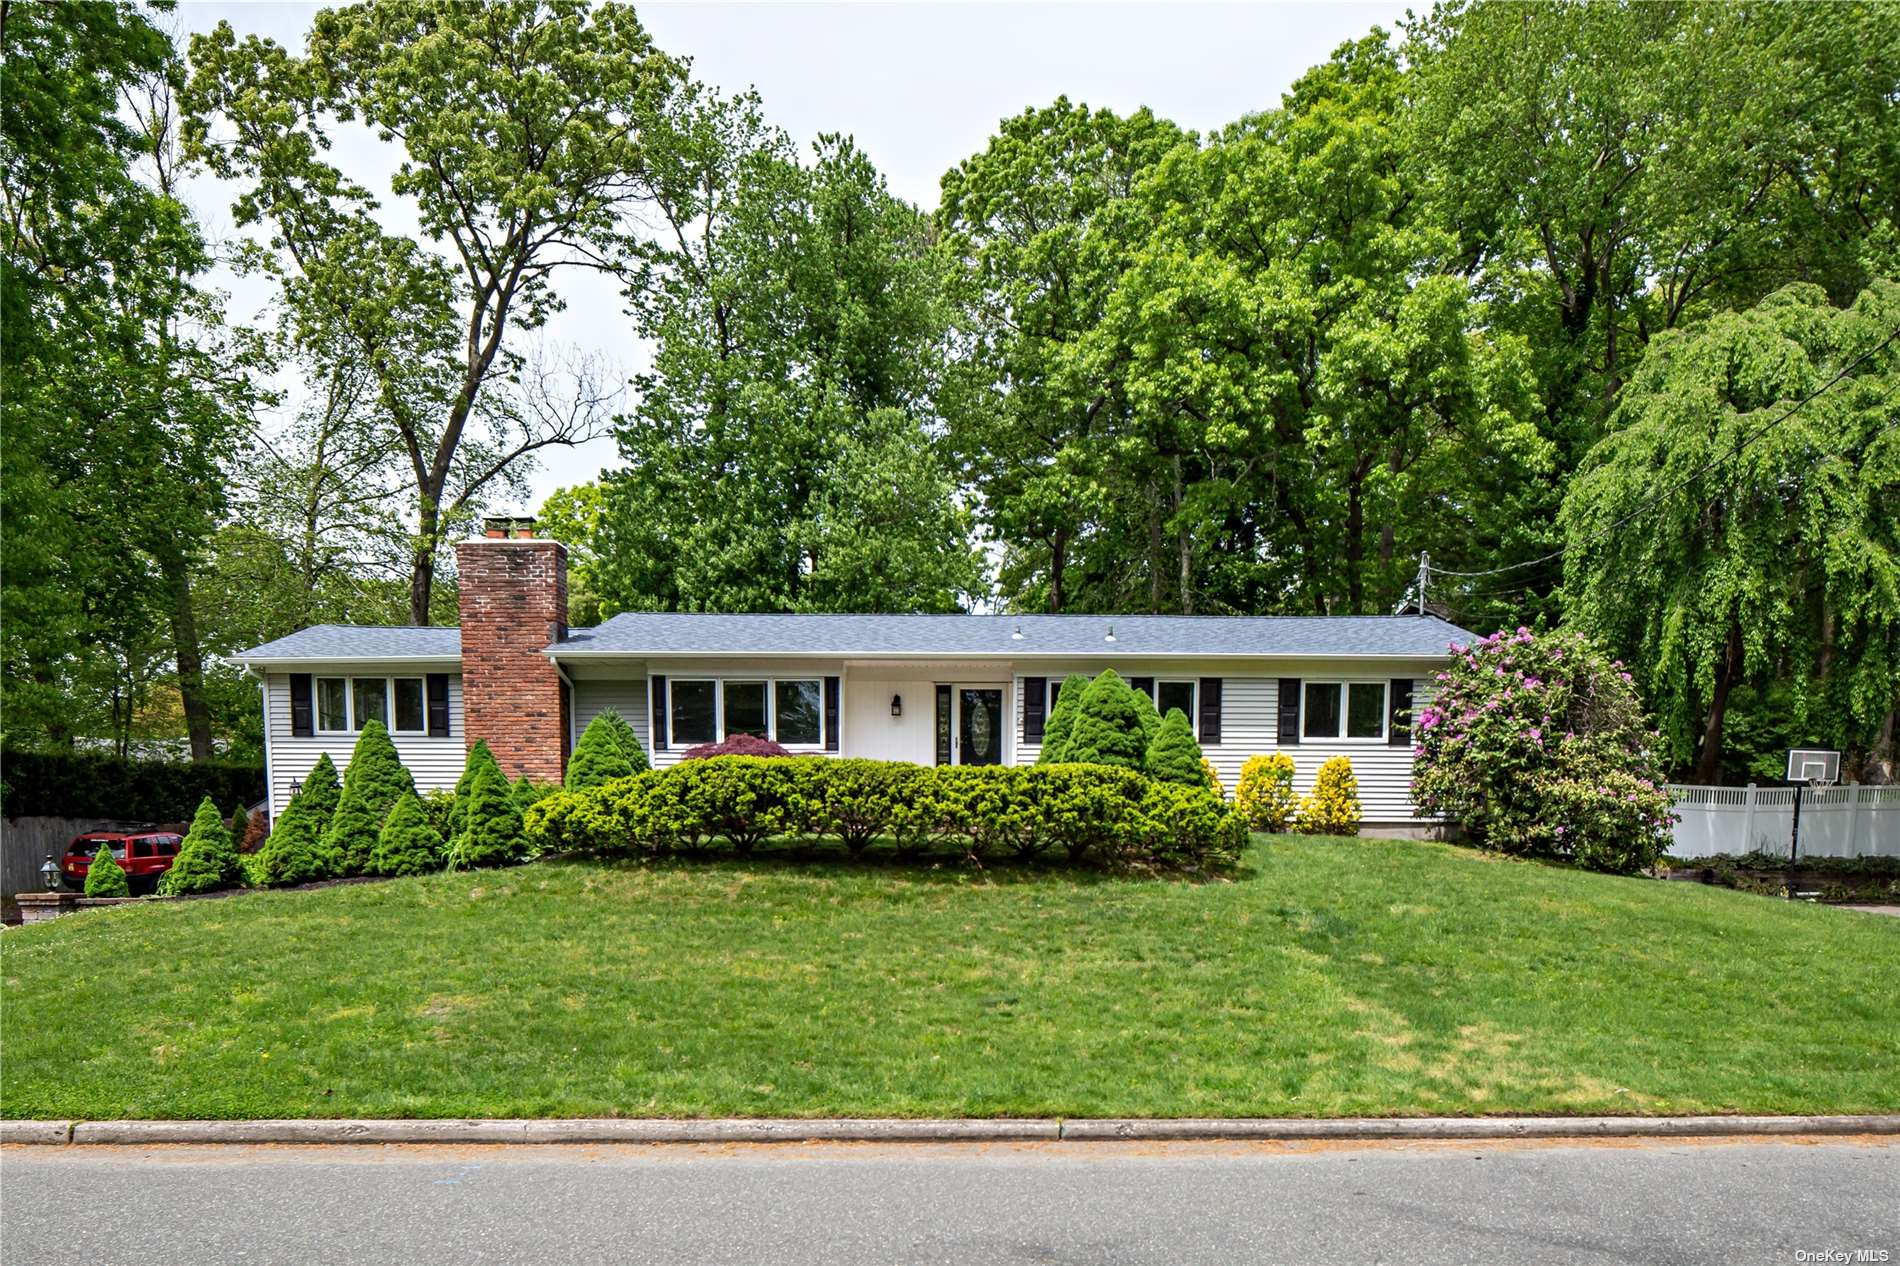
4, 0, 1900, 779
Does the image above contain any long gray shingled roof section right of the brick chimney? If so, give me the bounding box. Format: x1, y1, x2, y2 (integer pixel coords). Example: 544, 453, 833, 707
549, 612, 1474, 658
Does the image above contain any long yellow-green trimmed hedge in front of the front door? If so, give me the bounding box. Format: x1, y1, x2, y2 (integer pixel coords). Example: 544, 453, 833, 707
526, 757, 1246, 869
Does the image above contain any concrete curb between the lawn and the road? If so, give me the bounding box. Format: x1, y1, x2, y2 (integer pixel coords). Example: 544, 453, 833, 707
0, 1116, 1900, 1146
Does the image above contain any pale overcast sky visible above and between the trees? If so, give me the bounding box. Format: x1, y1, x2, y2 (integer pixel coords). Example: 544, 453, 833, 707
179, 0, 1406, 509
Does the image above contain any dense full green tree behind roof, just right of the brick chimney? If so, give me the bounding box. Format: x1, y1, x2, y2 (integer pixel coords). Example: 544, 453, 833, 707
591, 97, 979, 612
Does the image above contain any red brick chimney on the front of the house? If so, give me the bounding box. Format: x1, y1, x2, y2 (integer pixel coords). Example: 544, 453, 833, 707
456, 519, 568, 783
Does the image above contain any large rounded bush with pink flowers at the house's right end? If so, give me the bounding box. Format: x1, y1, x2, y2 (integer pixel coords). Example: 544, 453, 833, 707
1412, 629, 1672, 874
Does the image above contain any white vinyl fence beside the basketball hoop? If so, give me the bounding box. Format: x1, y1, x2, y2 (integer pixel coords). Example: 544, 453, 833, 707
1668, 783, 1900, 857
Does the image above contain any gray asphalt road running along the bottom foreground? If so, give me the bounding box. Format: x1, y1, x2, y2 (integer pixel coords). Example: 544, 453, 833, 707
0, 1139, 1900, 1266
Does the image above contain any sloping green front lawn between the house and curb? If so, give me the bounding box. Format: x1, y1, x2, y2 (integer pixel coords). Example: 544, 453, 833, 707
0, 838, 1900, 1118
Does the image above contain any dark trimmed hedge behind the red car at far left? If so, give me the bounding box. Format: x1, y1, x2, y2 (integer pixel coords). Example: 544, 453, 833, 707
0, 751, 264, 823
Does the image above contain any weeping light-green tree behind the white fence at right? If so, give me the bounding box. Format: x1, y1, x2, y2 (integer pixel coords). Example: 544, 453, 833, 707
1562, 281, 1900, 781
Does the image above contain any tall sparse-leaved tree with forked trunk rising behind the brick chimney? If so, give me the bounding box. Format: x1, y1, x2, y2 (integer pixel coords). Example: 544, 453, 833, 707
179, 0, 682, 623
